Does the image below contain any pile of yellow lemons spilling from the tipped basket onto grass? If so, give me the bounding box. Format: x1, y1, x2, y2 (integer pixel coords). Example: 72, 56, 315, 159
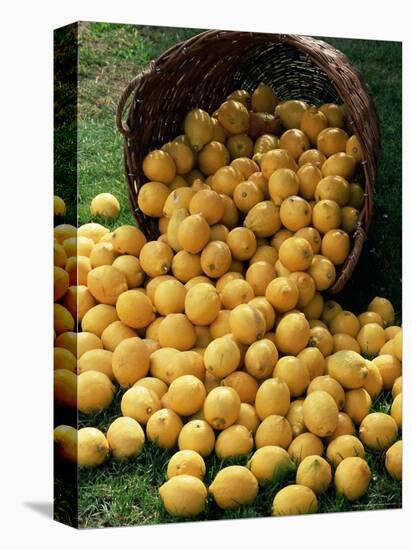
54, 85, 402, 516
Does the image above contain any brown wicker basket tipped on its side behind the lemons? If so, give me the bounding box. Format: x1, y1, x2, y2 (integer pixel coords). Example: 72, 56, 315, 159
116, 30, 380, 294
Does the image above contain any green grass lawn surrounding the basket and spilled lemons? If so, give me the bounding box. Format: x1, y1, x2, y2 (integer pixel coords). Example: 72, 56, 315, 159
55, 23, 402, 528
